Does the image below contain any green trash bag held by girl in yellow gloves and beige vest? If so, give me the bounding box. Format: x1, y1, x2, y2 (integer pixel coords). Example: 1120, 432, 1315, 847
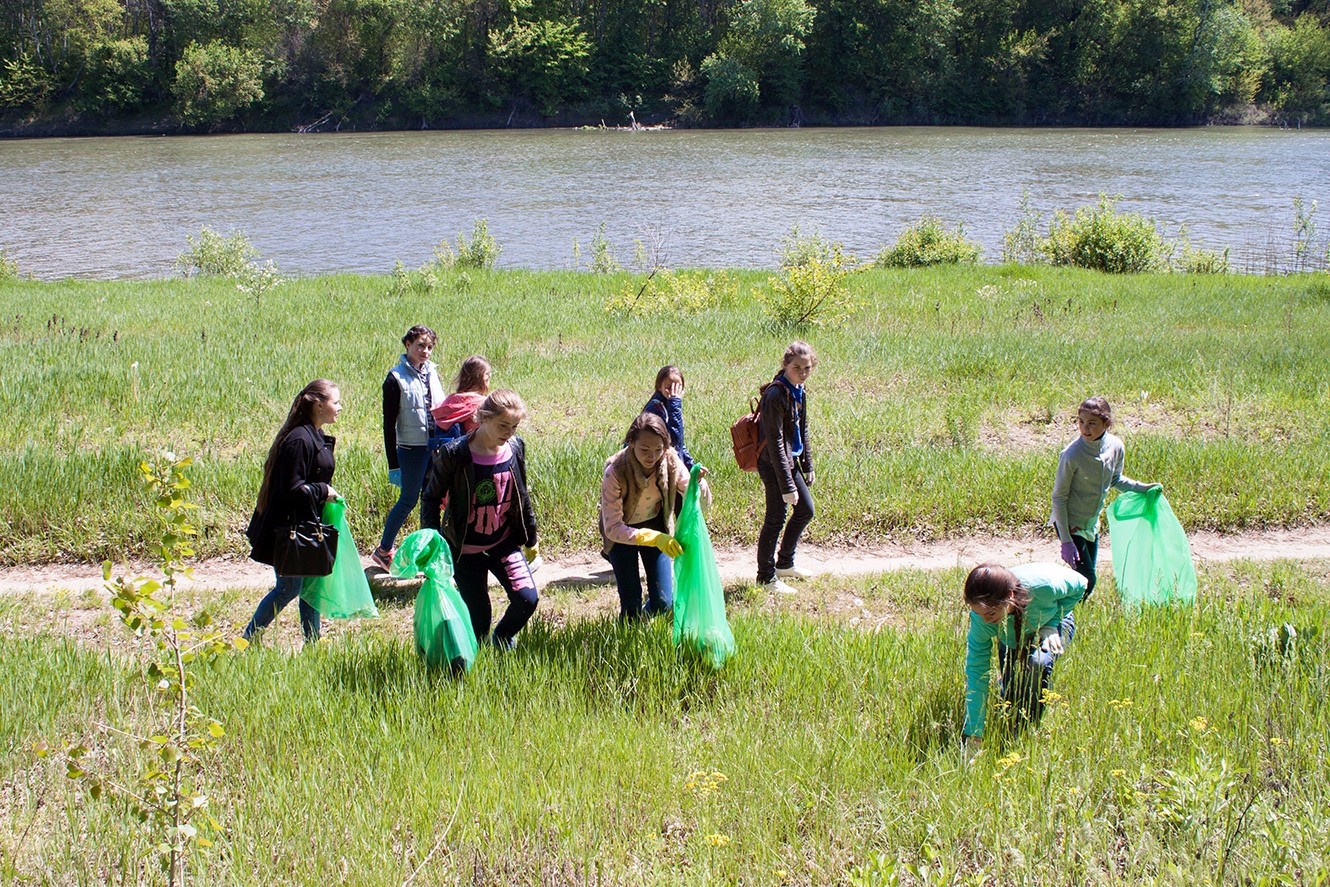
674, 464, 735, 669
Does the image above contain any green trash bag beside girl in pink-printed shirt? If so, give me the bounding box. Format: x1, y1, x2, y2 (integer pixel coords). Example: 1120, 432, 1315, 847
388, 529, 476, 670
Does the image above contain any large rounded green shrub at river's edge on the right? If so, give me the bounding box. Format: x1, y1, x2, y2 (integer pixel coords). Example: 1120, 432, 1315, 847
1041, 194, 1169, 274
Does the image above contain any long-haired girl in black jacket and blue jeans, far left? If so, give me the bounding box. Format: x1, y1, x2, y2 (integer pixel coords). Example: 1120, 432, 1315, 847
245, 379, 342, 642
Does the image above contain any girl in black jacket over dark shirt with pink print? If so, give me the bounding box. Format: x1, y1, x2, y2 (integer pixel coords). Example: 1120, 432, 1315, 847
420, 388, 540, 649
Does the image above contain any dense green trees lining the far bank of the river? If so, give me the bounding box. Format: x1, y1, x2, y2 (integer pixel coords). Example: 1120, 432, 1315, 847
0, 0, 1330, 130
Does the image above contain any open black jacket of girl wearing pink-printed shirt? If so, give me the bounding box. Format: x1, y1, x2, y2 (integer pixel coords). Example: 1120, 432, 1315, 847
420, 432, 536, 560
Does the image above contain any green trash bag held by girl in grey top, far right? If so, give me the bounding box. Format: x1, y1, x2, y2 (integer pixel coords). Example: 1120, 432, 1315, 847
1108, 489, 1196, 606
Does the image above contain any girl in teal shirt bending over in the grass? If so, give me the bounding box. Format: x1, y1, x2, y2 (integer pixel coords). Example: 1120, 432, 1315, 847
963, 564, 1087, 746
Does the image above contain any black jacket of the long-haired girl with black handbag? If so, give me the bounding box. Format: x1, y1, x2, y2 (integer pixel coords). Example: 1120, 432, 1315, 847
245, 423, 336, 564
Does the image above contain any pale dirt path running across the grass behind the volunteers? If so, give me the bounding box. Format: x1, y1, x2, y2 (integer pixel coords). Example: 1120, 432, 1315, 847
0, 525, 1330, 594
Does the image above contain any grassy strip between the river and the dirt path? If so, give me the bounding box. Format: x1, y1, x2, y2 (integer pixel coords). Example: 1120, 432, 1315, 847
0, 266, 1330, 564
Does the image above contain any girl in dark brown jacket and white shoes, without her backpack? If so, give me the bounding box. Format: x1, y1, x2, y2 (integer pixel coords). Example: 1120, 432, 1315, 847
757, 342, 818, 594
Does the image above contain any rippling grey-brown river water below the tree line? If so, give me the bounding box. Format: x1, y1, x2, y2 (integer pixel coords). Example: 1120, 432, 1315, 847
0, 128, 1330, 278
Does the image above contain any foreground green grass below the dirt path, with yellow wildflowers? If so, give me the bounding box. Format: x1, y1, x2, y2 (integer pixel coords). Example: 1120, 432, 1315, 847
0, 561, 1330, 886
